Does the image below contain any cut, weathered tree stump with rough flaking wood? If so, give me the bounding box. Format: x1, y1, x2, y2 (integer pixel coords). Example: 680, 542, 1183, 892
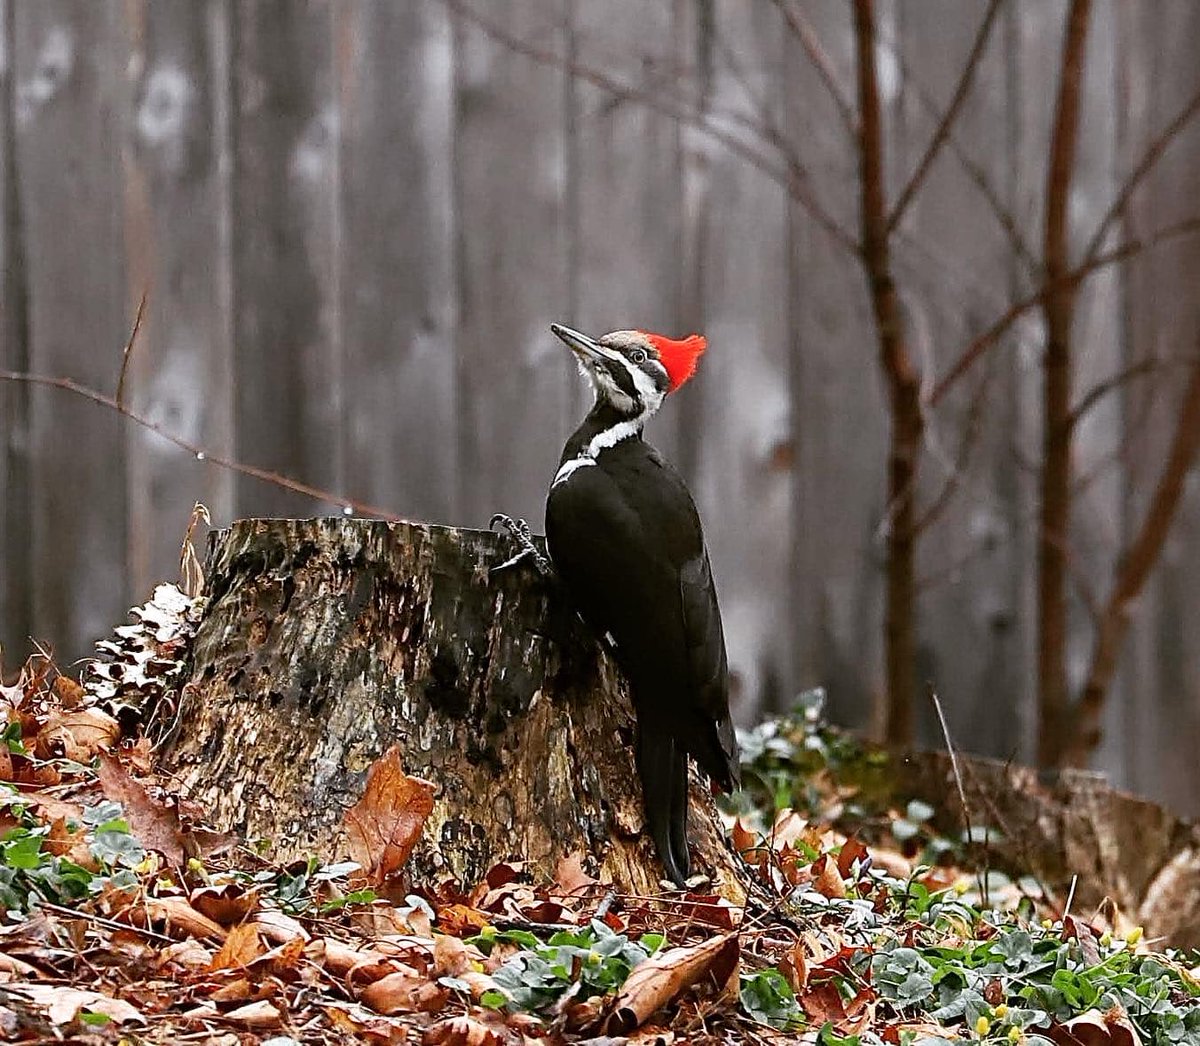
164, 518, 742, 900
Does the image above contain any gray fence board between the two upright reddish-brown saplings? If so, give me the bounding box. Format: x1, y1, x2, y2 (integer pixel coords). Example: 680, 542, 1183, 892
892, 0, 1037, 758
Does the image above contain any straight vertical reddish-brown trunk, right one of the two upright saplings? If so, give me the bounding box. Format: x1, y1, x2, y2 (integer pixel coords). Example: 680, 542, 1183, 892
1037, 0, 1091, 767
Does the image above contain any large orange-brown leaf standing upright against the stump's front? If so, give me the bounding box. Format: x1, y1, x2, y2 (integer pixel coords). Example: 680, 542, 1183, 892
344, 745, 433, 884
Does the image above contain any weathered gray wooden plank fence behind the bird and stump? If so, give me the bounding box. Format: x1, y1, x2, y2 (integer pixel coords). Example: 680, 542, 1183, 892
0, 0, 1200, 814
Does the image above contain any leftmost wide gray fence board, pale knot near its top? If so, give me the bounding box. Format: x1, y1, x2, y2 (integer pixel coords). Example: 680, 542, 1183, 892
12, 0, 128, 659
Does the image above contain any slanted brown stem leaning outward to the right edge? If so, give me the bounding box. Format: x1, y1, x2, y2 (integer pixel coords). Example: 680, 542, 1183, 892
1064, 350, 1200, 767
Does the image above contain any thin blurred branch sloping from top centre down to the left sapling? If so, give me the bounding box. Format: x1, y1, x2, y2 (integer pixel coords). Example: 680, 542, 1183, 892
442, 0, 858, 254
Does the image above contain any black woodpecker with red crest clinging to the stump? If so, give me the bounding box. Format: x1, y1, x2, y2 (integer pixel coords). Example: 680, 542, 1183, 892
496, 324, 739, 885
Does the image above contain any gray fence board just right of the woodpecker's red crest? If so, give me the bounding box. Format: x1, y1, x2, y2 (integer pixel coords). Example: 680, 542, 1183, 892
685, 2, 792, 719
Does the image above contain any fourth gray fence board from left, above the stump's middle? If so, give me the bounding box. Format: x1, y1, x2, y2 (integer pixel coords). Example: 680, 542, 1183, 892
334, 0, 458, 522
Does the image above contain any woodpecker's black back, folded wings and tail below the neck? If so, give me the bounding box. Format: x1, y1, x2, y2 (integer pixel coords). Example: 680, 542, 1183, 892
546, 439, 737, 880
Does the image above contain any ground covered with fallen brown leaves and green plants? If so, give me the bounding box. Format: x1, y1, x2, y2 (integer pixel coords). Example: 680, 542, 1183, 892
0, 592, 1200, 1046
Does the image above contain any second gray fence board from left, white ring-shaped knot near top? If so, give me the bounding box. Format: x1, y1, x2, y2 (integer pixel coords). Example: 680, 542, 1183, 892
124, 0, 234, 597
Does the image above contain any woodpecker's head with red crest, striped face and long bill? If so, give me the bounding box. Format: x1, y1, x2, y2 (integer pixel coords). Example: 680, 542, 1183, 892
550, 323, 707, 417
